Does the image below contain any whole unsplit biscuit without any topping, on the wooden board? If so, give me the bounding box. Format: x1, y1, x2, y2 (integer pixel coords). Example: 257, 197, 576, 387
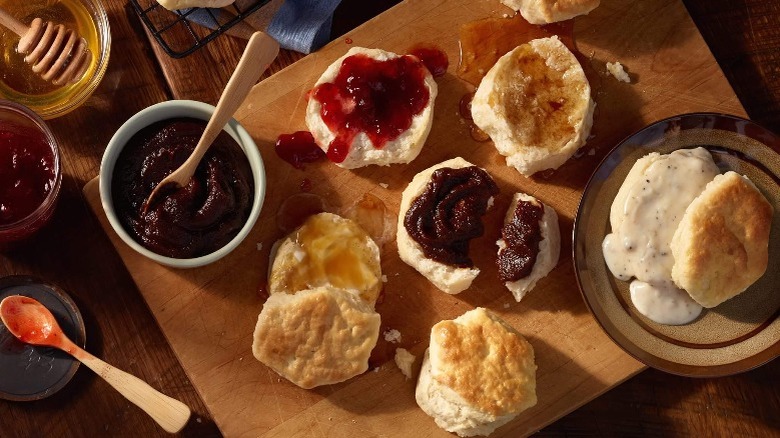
415, 308, 536, 436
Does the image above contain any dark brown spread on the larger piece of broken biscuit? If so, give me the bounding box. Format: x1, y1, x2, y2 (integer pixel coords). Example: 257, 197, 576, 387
404, 166, 498, 268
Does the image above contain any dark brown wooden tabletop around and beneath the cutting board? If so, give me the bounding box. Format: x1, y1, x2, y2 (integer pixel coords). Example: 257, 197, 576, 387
0, 0, 780, 437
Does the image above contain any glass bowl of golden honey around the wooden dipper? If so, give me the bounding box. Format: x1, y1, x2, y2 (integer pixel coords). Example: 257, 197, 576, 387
0, 0, 111, 120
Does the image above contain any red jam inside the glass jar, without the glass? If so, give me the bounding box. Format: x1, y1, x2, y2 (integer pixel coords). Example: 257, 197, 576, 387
0, 124, 57, 226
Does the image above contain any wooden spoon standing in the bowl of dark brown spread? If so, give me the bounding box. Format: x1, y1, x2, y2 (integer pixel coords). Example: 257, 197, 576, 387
143, 32, 279, 212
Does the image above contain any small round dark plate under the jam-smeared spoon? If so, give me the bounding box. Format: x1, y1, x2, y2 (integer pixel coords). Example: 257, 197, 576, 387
0, 275, 86, 401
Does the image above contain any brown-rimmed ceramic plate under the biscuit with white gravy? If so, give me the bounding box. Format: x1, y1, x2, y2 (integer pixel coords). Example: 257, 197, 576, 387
572, 113, 780, 377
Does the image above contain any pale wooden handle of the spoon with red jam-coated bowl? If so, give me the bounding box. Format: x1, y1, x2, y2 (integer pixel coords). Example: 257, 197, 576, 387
72, 345, 190, 433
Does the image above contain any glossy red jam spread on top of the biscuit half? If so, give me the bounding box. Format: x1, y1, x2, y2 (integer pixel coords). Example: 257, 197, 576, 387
311, 51, 430, 163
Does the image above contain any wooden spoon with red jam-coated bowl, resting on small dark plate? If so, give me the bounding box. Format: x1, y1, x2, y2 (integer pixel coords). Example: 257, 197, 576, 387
0, 295, 190, 433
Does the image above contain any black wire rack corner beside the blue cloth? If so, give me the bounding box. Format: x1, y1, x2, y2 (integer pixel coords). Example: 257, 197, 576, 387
130, 0, 270, 58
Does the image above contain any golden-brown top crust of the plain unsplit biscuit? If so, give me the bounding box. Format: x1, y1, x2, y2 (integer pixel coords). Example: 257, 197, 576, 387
430, 307, 536, 416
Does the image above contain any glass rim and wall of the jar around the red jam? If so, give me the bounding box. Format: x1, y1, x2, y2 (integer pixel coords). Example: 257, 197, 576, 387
0, 100, 62, 249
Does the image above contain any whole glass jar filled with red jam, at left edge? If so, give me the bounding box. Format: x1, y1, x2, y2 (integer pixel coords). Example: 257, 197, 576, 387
0, 100, 62, 249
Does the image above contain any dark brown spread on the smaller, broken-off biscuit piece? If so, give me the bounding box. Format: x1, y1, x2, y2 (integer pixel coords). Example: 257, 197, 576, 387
498, 200, 544, 281
